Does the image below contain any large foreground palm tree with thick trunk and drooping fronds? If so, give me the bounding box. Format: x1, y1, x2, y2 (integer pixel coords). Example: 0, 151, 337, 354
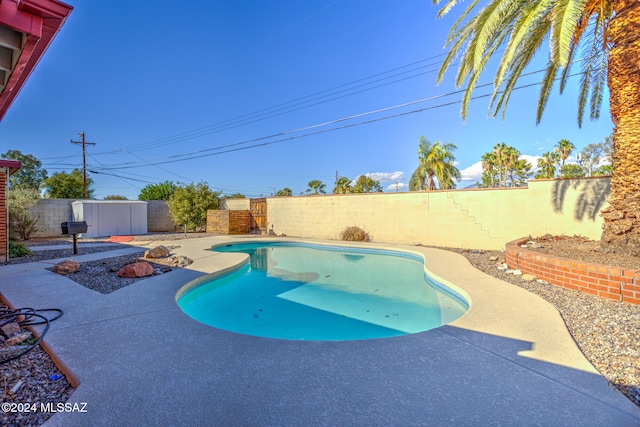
435, 0, 640, 254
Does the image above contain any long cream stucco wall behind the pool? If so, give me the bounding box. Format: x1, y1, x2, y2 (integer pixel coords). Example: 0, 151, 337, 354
267, 178, 610, 249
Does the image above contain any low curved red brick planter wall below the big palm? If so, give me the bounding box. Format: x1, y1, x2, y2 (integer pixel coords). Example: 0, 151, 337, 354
505, 239, 640, 304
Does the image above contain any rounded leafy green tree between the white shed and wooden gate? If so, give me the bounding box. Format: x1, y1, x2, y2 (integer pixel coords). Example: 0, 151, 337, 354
167, 182, 221, 231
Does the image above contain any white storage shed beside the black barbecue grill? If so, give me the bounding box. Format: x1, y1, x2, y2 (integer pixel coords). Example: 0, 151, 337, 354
71, 200, 147, 237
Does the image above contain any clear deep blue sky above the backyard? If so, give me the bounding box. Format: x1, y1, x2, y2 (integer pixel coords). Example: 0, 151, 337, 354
0, 0, 612, 200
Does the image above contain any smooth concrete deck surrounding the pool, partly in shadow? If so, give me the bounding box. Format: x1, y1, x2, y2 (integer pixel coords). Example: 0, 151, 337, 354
0, 236, 640, 425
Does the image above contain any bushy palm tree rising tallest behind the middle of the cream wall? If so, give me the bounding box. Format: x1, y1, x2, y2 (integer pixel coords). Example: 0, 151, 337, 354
409, 136, 460, 190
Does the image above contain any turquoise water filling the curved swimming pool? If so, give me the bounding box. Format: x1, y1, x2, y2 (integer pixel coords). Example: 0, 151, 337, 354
178, 242, 468, 340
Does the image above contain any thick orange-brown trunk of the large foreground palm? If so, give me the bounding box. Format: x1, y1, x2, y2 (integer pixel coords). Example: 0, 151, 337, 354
601, 0, 640, 255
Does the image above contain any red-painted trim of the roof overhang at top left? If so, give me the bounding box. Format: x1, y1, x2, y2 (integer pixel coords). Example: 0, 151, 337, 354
0, 0, 73, 120
